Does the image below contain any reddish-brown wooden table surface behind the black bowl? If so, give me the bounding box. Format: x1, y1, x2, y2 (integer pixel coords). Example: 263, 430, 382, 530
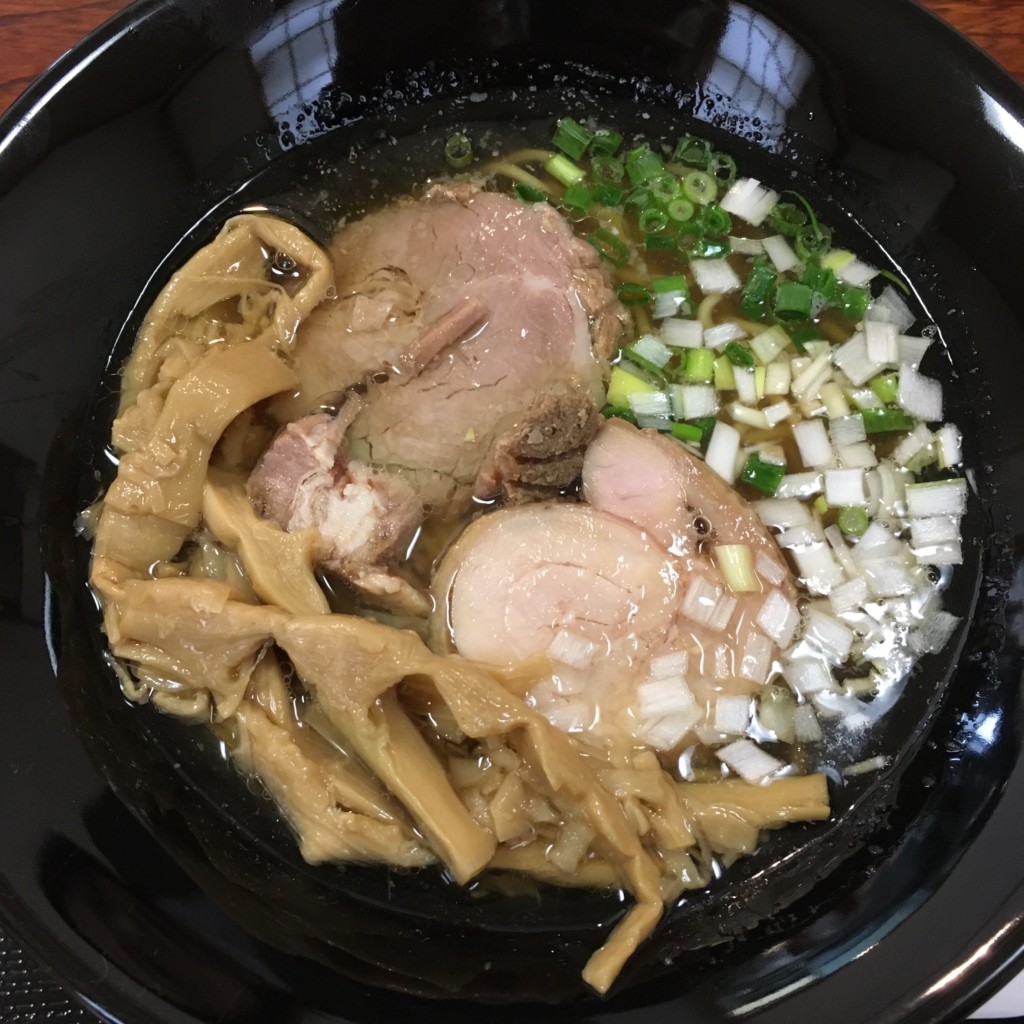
0, 0, 1024, 111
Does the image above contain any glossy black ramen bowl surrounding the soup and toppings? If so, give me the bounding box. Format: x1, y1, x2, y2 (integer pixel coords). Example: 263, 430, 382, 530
0, 0, 1024, 1024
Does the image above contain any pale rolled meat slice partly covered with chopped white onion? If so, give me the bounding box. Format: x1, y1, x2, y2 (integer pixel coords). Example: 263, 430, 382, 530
433, 421, 799, 750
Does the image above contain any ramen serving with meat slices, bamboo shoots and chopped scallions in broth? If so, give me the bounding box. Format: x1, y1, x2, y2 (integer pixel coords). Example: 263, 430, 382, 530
83, 118, 967, 992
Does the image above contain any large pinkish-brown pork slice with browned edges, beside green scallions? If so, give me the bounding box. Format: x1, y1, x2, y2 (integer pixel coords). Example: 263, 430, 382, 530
311, 183, 626, 511
